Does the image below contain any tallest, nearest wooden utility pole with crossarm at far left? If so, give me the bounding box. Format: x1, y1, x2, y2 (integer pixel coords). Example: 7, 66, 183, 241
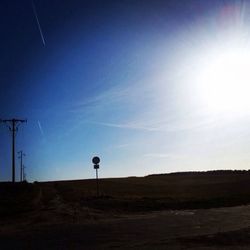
0, 119, 27, 183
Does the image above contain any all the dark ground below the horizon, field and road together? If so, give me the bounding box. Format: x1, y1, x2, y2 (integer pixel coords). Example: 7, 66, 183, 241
0, 171, 250, 249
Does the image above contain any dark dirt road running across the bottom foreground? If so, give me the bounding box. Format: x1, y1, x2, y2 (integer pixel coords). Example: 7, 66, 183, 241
0, 206, 250, 249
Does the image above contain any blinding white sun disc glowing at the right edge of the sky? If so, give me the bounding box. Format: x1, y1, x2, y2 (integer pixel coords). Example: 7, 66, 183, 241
196, 45, 250, 114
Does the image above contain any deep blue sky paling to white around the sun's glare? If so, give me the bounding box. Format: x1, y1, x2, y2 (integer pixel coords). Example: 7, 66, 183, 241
0, 0, 250, 181
